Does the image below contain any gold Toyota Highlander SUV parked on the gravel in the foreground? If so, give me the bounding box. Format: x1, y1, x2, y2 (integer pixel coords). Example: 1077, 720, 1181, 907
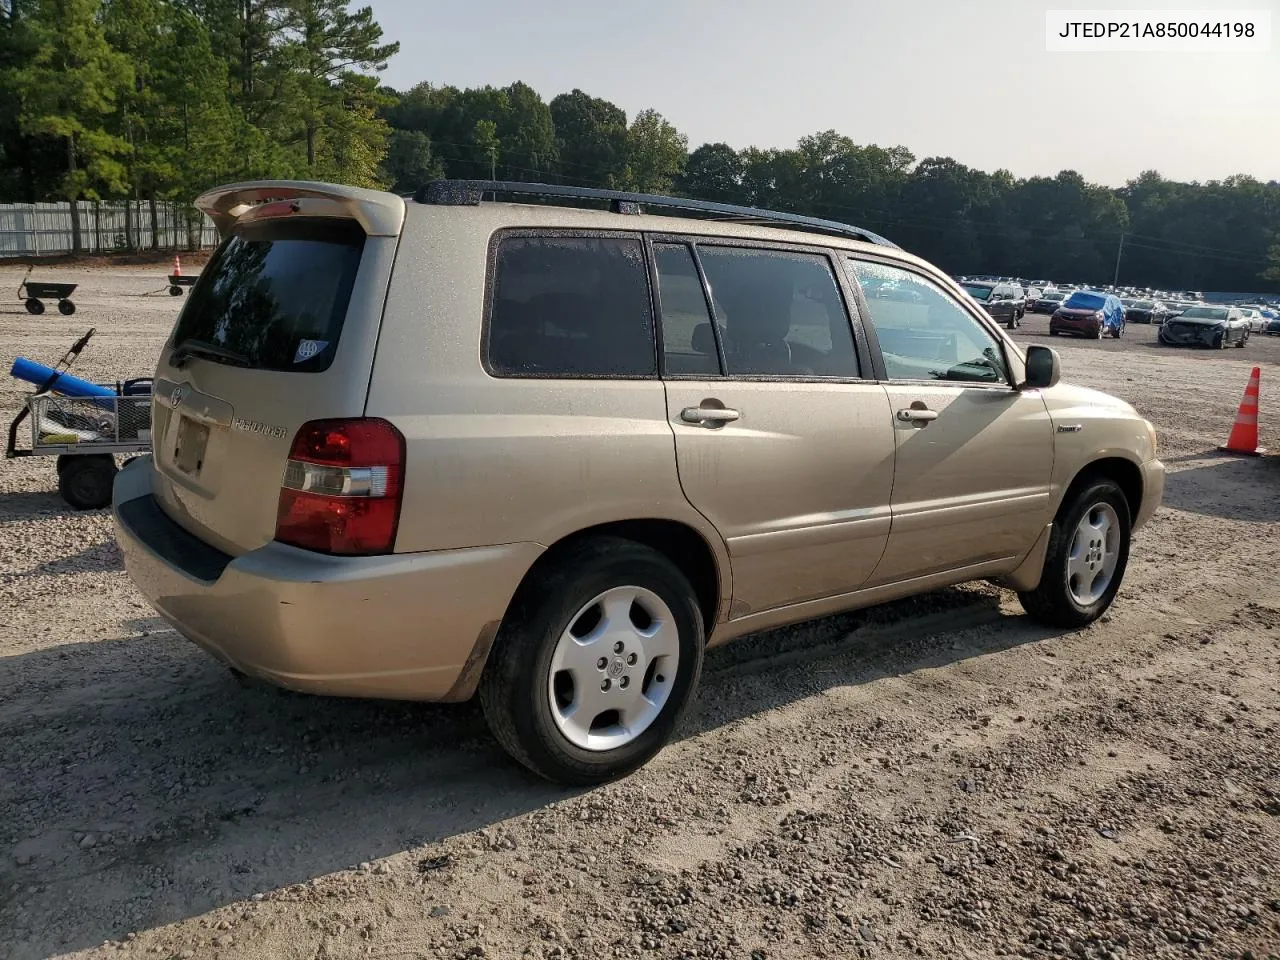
113, 182, 1164, 783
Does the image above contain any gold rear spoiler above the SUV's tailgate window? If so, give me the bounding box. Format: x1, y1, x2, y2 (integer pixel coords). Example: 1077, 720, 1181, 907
196, 180, 404, 237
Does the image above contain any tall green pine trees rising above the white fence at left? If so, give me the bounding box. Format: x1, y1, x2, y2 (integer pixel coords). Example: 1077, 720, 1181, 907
0, 0, 399, 202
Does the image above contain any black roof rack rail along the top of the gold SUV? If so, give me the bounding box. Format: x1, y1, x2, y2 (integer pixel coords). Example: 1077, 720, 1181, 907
413, 180, 897, 247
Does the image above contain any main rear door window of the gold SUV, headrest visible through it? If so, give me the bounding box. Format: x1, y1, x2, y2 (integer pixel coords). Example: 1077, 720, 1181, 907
690, 246, 858, 378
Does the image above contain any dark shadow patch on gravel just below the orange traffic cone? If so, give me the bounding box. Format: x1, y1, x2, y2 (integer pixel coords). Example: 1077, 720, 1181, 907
1165, 452, 1280, 524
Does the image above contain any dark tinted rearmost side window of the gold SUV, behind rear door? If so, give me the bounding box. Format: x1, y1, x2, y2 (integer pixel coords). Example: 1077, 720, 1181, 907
488, 236, 658, 378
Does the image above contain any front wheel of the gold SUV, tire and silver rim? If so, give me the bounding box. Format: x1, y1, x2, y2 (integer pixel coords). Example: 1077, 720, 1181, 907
1018, 477, 1133, 627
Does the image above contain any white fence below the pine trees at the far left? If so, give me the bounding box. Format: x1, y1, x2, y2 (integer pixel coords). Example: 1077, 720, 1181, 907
0, 200, 218, 257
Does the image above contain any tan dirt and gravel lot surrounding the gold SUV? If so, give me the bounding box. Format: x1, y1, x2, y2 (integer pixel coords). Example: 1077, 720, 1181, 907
0, 268, 1280, 960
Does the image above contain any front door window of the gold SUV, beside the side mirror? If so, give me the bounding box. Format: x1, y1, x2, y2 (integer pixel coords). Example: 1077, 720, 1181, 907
849, 260, 1009, 383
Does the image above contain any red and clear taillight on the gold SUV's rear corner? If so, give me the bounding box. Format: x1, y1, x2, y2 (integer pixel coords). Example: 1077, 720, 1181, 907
275, 417, 404, 556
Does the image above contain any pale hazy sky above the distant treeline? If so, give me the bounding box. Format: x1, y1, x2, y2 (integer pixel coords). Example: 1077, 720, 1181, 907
371, 0, 1280, 186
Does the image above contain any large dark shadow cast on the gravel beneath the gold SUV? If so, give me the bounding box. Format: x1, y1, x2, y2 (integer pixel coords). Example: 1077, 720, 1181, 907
0, 585, 1053, 960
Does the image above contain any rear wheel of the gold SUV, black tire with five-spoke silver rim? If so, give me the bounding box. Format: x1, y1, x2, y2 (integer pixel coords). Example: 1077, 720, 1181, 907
480, 538, 704, 786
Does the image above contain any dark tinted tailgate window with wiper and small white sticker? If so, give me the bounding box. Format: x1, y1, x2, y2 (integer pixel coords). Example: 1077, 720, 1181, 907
173, 220, 365, 372
